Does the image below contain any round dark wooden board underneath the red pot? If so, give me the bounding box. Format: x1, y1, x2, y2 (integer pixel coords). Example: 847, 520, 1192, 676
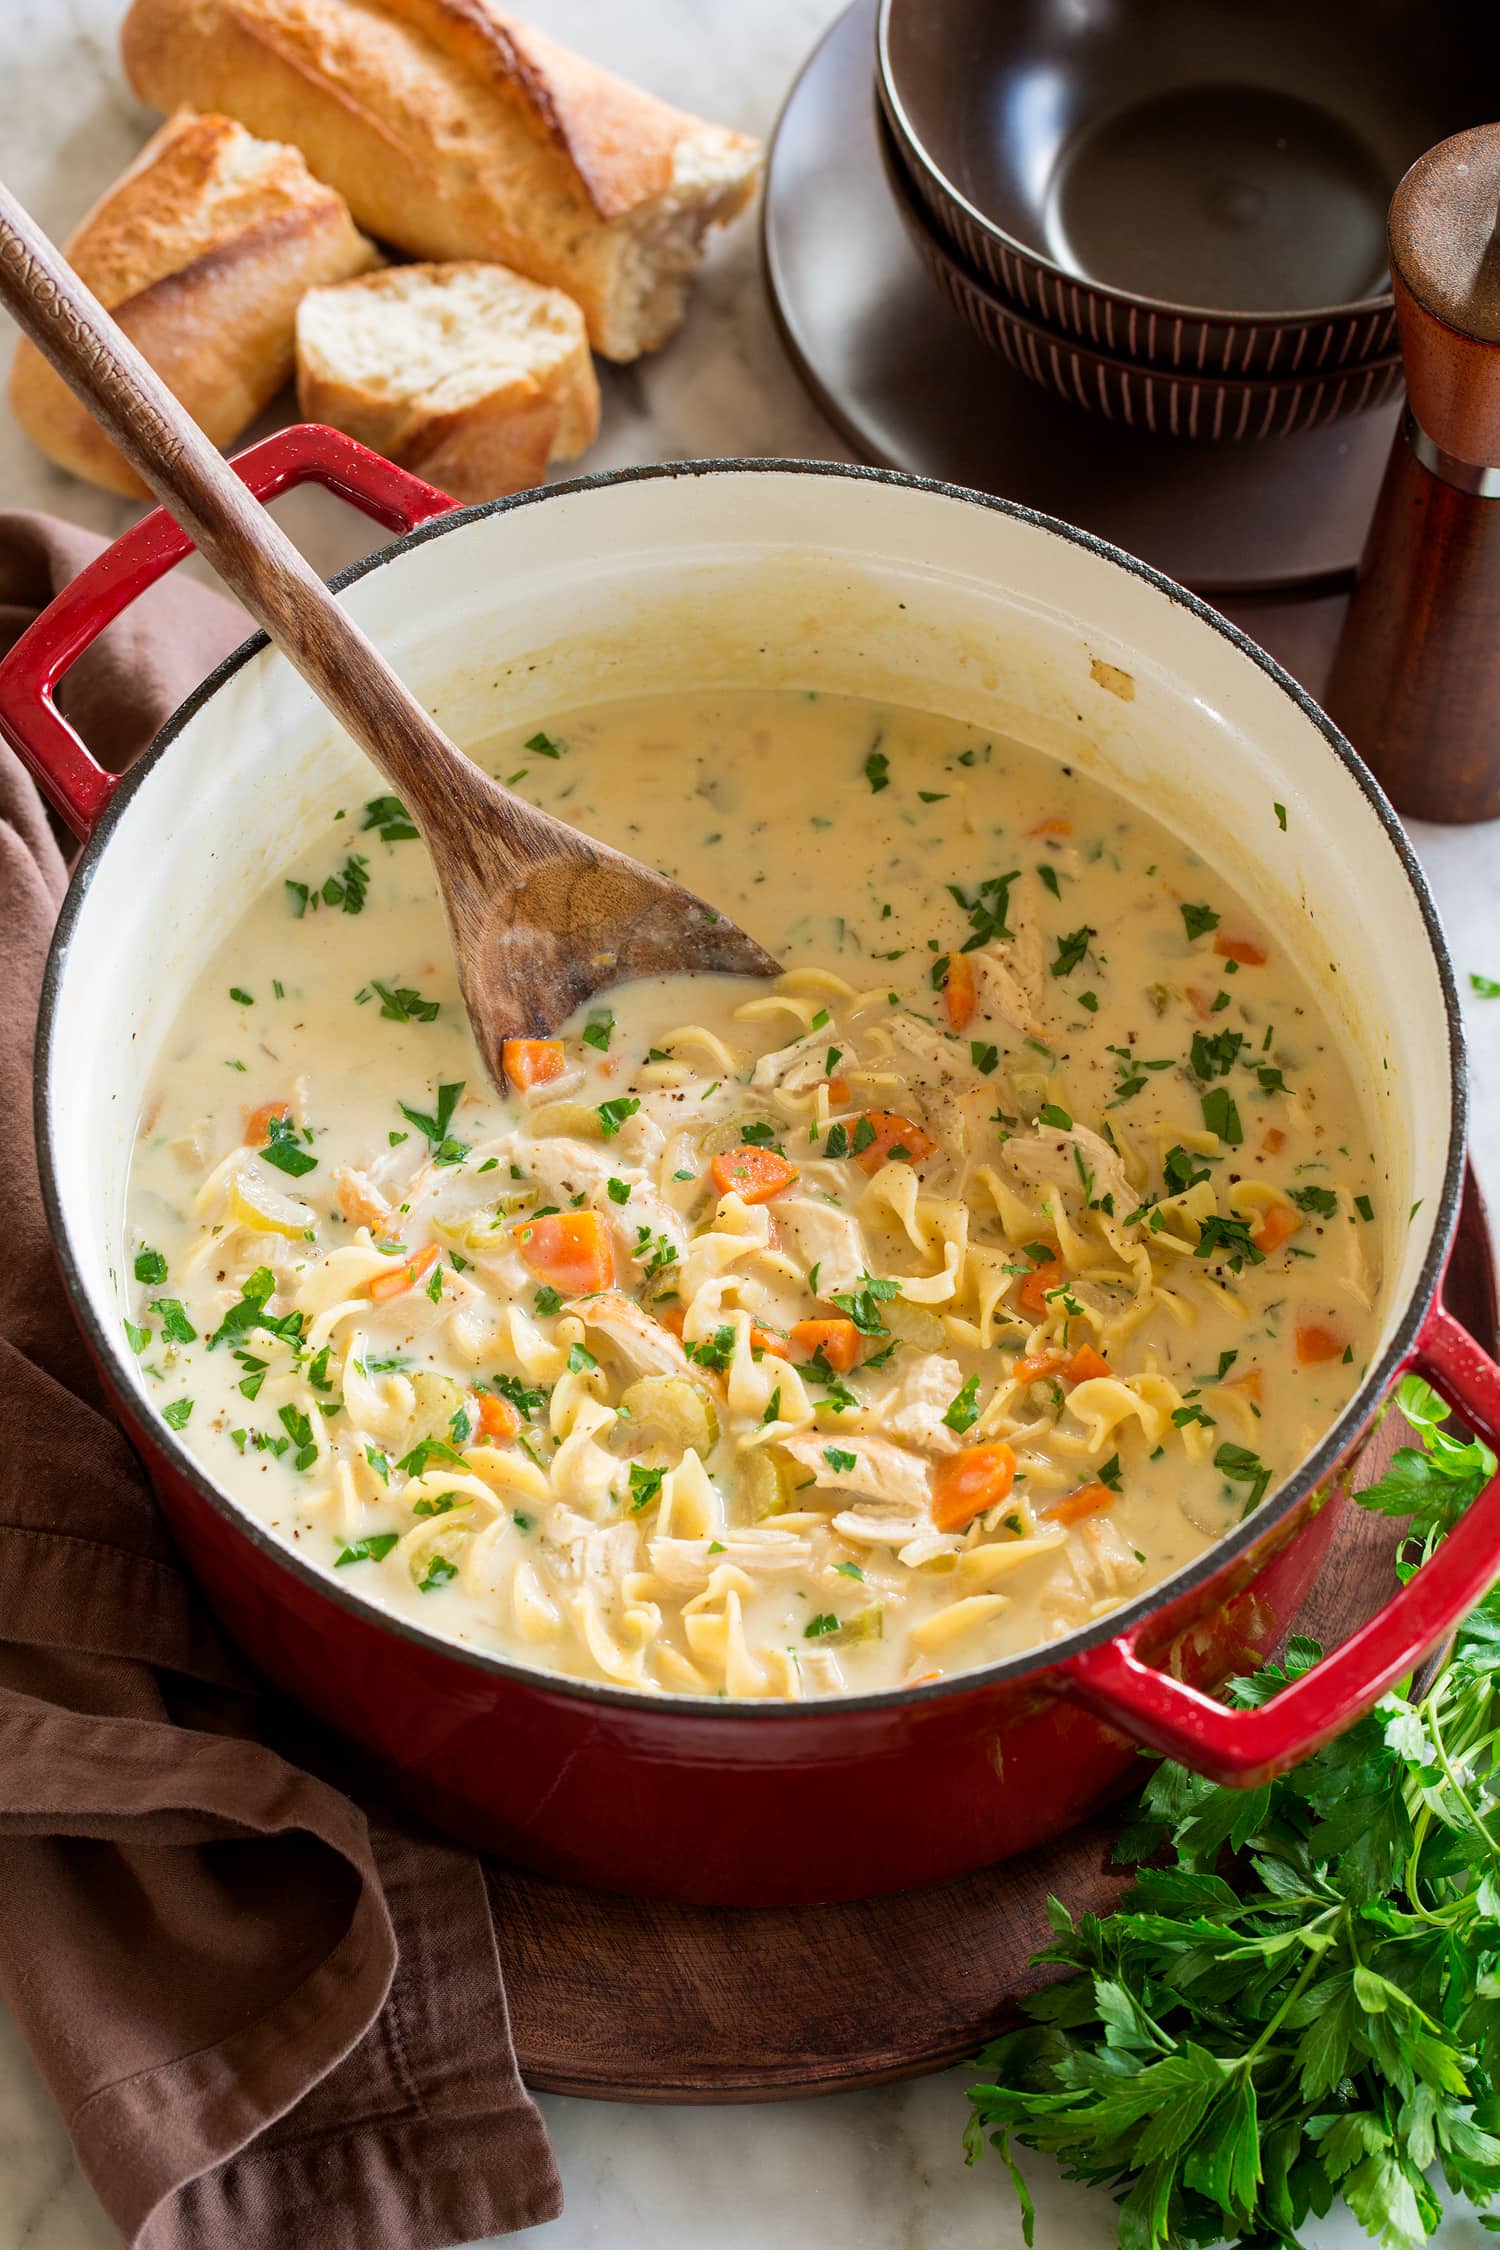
490, 1177, 1500, 2102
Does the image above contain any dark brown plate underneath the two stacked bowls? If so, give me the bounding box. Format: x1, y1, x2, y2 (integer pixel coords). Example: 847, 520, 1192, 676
762, 0, 1399, 594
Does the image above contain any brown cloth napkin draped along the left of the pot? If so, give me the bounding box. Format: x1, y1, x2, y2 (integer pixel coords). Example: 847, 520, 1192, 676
0, 513, 562, 2250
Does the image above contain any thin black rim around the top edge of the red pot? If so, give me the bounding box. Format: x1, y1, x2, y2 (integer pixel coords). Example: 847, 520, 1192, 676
34, 459, 1469, 1728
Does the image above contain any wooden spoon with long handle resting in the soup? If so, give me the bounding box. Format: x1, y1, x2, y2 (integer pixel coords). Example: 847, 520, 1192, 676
0, 185, 780, 1089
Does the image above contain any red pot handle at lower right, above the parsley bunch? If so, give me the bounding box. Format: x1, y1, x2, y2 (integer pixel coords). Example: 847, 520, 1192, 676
1059, 1305, 1500, 1789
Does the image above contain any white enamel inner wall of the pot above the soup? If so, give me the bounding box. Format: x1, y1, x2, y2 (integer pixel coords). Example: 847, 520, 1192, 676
38, 461, 1464, 1701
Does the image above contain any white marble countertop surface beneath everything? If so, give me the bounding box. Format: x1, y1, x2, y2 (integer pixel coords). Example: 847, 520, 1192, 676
0, 0, 1500, 2250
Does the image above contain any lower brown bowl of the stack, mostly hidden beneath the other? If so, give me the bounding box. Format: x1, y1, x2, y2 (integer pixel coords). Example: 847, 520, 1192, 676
879, 126, 1401, 439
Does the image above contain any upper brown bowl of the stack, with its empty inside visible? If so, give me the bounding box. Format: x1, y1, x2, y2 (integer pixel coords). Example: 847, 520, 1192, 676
877, 0, 1500, 385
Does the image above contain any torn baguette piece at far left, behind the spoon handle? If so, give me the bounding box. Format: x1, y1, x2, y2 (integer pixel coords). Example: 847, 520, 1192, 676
11, 113, 380, 497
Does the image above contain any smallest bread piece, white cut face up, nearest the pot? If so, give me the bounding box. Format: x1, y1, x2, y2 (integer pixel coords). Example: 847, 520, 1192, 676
297, 261, 598, 500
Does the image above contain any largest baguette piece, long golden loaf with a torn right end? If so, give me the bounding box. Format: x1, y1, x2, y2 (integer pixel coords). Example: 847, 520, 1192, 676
121, 0, 760, 360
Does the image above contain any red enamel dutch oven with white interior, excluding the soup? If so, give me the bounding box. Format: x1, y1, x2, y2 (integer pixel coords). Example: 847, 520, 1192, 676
0, 428, 1500, 1904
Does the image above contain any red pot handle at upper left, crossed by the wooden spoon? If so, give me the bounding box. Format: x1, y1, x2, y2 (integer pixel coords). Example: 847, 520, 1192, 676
0, 423, 459, 837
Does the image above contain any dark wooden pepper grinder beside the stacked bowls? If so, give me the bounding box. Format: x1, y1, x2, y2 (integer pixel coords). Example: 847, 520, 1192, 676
1325, 126, 1500, 821
